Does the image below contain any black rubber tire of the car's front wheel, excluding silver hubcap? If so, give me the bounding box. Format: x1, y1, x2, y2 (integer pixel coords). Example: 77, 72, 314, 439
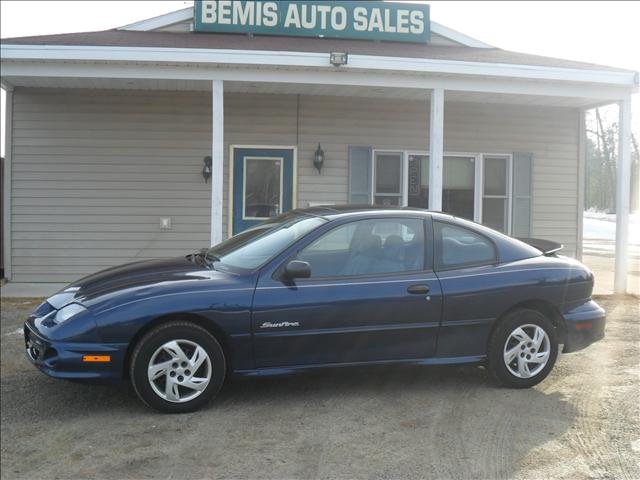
129, 321, 226, 413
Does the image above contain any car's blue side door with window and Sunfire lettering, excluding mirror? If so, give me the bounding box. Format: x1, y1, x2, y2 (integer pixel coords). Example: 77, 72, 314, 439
252, 215, 442, 367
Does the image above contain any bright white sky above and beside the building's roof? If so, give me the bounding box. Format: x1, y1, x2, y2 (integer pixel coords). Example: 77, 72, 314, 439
0, 0, 640, 155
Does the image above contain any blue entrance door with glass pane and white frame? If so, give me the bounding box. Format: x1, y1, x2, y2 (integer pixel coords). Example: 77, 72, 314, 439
232, 147, 294, 235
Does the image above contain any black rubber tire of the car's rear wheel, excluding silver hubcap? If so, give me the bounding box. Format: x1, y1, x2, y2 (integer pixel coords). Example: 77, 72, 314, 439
487, 308, 558, 388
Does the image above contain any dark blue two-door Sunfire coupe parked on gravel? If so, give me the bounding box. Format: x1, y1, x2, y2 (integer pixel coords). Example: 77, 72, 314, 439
24, 206, 605, 412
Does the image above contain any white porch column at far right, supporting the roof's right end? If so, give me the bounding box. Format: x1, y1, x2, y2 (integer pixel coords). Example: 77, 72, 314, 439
613, 95, 631, 293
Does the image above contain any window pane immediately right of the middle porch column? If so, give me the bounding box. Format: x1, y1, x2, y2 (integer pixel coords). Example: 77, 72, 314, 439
442, 157, 476, 220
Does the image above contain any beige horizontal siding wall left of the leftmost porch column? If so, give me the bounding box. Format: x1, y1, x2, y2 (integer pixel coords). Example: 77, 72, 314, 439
12, 89, 211, 282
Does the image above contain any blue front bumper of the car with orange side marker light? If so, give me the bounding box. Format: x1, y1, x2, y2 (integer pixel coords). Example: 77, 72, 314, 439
24, 320, 127, 383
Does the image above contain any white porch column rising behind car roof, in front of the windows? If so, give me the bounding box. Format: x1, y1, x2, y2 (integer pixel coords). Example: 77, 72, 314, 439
429, 88, 444, 211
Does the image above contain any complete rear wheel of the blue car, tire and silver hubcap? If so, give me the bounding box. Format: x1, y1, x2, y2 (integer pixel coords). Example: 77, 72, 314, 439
488, 309, 558, 388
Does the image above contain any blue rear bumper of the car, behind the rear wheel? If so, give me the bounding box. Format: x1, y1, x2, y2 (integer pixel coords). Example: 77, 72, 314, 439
563, 300, 607, 353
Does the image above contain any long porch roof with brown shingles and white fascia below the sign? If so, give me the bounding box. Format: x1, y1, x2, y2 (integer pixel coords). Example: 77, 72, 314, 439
0, 23, 640, 108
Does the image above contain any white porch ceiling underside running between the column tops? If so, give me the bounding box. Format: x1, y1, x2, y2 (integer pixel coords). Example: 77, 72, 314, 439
3, 76, 602, 108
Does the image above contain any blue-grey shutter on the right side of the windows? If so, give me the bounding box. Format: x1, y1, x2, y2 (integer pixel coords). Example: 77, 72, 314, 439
511, 152, 533, 238
